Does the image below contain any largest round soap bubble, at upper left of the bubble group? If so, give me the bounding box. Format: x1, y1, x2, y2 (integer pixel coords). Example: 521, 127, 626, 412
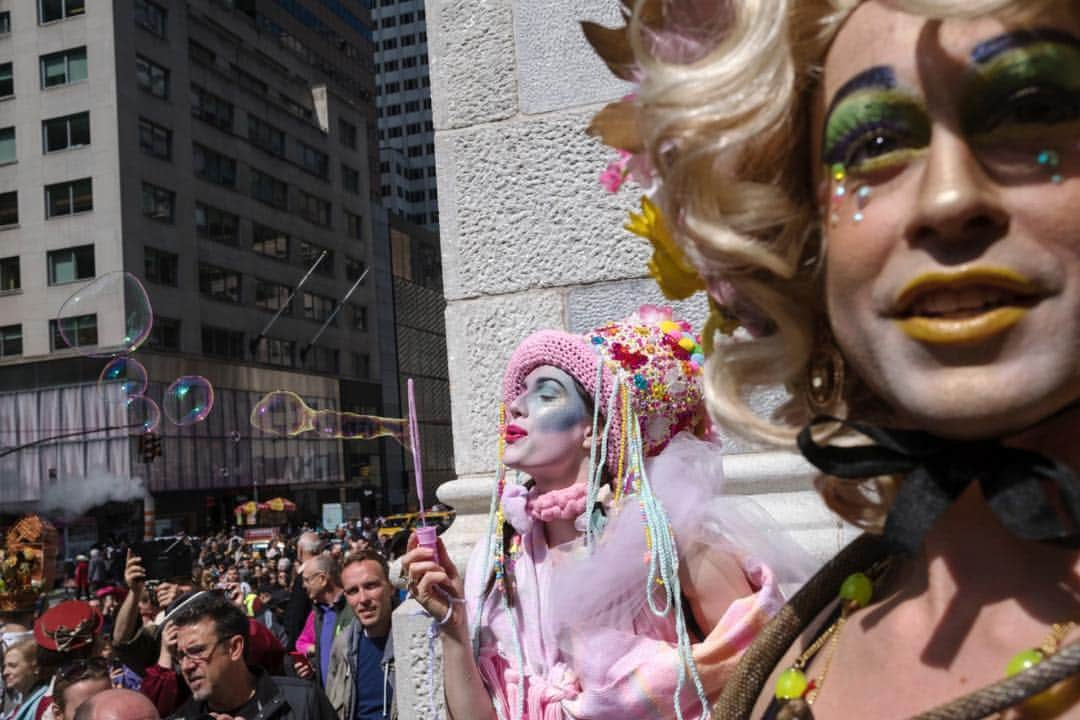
56, 270, 153, 357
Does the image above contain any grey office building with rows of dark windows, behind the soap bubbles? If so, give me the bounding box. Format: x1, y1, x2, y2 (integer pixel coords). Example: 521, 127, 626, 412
0, 0, 412, 535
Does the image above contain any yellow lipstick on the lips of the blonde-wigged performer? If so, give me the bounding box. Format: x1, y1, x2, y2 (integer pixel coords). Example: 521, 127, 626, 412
895, 268, 1040, 344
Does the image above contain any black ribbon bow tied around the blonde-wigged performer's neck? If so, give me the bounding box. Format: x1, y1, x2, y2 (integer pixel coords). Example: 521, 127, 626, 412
798, 416, 1080, 555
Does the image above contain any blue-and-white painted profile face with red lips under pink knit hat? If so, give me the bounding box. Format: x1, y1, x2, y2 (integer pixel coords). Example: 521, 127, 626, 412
503, 365, 592, 489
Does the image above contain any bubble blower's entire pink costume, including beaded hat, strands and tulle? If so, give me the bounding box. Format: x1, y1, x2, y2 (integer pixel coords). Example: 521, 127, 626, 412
465, 307, 813, 720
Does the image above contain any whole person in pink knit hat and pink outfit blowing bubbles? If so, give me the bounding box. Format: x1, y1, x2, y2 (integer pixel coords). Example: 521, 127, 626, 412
403, 307, 809, 720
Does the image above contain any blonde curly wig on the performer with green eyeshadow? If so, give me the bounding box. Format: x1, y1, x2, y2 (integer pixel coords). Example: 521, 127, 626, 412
627, 0, 1069, 530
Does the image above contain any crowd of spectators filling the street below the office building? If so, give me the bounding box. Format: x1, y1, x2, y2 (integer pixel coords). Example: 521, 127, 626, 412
0, 520, 408, 720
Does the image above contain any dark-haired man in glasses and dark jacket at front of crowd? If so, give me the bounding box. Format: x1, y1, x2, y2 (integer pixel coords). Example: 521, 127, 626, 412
170, 593, 336, 720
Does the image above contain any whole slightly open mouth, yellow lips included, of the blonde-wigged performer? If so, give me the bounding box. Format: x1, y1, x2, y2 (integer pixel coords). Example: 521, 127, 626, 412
893, 268, 1042, 344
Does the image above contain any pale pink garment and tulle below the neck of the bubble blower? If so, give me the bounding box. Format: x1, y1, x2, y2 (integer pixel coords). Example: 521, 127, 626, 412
465, 434, 813, 720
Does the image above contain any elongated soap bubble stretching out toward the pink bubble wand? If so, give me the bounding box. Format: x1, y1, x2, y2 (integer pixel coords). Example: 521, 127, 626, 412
251, 390, 408, 447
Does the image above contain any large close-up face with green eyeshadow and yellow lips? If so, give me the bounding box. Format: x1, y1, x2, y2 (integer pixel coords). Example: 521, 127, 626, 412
811, 2, 1080, 437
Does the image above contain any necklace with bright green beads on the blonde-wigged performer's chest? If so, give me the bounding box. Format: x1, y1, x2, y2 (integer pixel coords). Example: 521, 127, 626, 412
774, 558, 1077, 720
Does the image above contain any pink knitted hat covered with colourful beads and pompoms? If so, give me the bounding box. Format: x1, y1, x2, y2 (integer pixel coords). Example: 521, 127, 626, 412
502, 305, 705, 477
